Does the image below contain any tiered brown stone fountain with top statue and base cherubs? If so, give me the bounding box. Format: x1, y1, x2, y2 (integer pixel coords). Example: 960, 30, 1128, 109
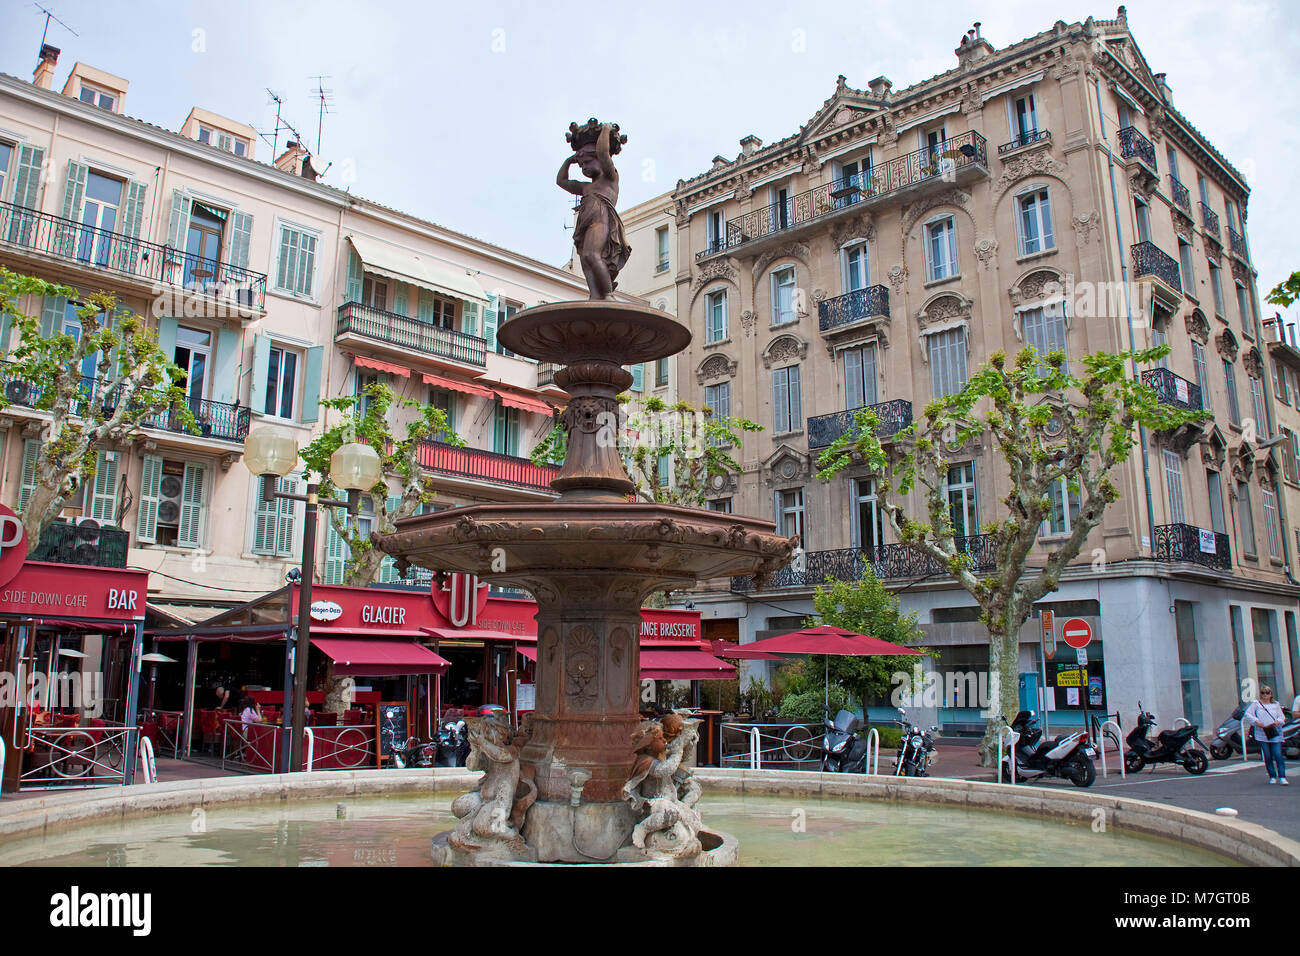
377, 120, 796, 865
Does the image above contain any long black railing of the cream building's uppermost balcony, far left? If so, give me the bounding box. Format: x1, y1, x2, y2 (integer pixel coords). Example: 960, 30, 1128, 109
0, 203, 267, 311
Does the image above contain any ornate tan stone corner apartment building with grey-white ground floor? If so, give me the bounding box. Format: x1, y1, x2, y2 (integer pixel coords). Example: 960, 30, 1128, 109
672, 8, 1300, 728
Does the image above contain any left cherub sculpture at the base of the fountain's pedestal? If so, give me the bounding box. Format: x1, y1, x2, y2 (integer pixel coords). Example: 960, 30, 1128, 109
449, 715, 537, 853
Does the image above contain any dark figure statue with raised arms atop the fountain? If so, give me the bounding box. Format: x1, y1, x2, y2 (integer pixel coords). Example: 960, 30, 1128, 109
555, 117, 632, 299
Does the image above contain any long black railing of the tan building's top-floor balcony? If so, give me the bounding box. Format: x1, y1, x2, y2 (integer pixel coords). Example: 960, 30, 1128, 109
696, 130, 988, 259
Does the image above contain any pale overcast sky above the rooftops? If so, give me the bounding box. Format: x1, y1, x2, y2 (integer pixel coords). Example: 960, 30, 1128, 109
0, 0, 1300, 325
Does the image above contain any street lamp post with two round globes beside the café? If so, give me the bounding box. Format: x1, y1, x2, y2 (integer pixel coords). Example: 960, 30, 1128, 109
243, 425, 384, 771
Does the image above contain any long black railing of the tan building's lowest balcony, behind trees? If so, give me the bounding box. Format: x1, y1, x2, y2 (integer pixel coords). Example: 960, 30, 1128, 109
731, 535, 997, 592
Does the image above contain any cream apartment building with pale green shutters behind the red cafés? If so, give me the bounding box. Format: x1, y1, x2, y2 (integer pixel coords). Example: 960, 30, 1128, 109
0, 47, 584, 620
